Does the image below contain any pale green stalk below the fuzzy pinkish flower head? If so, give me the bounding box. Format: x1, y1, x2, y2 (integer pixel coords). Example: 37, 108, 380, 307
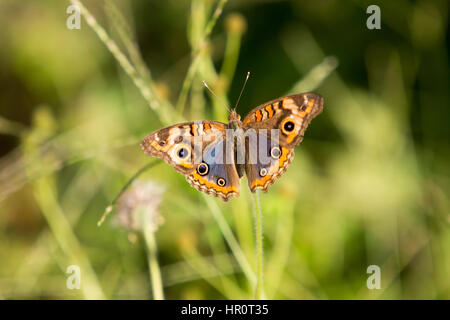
140, 210, 164, 300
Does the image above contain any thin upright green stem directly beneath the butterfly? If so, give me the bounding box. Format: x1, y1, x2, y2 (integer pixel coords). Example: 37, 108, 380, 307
254, 190, 265, 300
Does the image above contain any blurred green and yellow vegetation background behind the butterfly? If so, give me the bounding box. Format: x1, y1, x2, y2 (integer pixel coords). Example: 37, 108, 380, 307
0, 0, 450, 299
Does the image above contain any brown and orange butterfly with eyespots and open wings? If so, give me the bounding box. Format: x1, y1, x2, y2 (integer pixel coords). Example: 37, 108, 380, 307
141, 93, 323, 201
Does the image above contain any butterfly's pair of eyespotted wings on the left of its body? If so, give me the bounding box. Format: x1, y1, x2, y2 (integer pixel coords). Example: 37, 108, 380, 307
141, 121, 240, 201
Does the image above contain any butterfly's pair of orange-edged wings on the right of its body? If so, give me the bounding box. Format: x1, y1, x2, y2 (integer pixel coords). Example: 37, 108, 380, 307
243, 93, 323, 192
